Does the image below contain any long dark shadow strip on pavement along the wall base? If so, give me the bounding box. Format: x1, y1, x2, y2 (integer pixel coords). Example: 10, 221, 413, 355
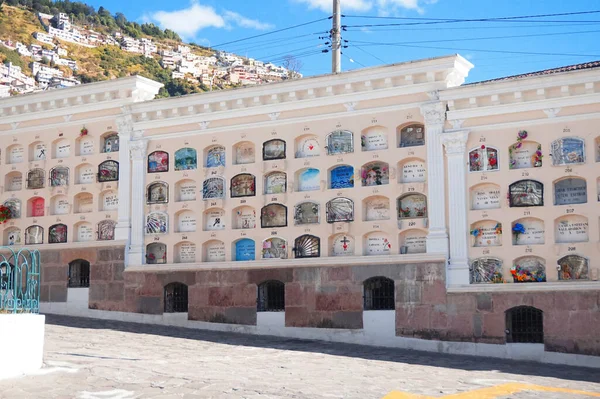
46, 315, 600, 383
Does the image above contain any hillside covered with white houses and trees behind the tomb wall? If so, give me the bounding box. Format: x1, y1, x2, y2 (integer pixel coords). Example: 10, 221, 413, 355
0, 3, 302, 97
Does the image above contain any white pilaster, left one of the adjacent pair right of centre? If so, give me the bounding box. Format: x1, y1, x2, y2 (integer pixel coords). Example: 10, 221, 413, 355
421, 101, 448, 255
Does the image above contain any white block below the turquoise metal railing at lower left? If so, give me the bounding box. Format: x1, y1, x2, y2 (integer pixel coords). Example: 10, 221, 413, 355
0, 314, 46, 379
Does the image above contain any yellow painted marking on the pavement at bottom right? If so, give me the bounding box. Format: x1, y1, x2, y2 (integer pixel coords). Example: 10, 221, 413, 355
383, 382, 600, 399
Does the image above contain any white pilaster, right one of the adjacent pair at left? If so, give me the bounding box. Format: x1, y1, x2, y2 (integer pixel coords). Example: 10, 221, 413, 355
127, 139, 148, 265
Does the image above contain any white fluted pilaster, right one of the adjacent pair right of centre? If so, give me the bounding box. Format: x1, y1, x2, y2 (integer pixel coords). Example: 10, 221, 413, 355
441, 130, 469, 286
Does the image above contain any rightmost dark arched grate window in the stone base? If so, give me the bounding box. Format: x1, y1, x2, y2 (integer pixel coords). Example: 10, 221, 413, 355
506, 306, 544, 344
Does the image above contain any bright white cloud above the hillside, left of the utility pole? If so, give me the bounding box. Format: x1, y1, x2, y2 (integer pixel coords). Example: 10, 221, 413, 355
148, 0, 273, 39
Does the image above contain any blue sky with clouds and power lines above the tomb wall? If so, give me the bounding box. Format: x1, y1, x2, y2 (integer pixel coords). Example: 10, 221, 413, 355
87, 0, 600, 82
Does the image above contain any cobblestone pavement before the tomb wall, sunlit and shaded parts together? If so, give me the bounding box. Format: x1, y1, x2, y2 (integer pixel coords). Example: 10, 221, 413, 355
0, 316, 600, 399
